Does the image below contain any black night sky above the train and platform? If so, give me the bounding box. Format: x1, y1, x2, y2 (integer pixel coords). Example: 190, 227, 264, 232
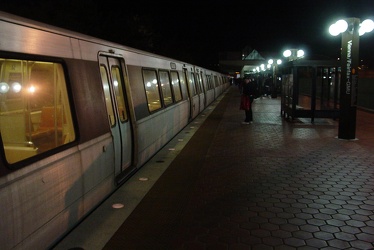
0, 0, 374, 71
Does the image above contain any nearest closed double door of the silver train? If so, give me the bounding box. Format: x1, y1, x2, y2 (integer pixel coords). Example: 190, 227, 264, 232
99, 55, 134, 182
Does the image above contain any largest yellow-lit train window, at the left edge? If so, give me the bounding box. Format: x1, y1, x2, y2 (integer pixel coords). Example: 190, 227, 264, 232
0, 58, 75, 164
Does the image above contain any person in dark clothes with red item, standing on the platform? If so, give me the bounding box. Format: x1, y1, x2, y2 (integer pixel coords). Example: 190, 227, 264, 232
240, 76, 255, 124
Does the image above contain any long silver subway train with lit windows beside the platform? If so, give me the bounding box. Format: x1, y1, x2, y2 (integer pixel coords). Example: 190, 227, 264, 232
0, 12, 229, 249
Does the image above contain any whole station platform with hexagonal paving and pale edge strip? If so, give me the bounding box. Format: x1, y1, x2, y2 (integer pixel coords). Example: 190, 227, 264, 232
53, 86, 374, 250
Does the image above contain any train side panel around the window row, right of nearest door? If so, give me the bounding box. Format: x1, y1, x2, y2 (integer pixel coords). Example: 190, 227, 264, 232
127, 57, 189, 166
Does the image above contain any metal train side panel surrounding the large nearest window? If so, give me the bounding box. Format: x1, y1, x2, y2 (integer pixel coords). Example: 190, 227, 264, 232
0, 17, 115, 249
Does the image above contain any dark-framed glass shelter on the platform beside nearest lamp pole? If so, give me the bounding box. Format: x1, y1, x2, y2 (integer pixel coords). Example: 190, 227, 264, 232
281, 59, 340, 122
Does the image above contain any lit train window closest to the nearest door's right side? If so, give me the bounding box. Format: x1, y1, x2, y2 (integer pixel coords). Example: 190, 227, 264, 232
143, 69, 161, 112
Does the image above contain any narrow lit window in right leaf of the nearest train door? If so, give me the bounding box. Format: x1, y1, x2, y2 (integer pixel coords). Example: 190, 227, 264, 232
112, 66, 127, 122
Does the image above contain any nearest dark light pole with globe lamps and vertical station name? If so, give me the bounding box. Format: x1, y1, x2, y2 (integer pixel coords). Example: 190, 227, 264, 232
329, 18, 374, 140
